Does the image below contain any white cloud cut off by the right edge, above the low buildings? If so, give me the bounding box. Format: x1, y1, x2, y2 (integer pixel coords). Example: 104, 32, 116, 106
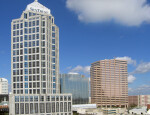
133, 62, 150, 73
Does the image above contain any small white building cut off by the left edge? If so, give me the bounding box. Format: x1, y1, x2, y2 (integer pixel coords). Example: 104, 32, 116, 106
0, 78, 8, 94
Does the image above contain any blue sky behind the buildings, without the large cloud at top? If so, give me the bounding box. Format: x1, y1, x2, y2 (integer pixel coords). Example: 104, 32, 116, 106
0, 0, 150, 93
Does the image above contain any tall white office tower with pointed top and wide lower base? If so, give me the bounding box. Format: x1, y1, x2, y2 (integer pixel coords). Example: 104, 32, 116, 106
9, 0, 72, 115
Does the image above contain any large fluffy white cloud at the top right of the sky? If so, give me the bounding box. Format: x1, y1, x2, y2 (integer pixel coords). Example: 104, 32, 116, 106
66, 0, 150, 26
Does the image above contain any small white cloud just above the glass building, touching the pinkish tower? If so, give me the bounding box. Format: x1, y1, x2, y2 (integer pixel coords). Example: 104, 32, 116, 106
69, 65, 90, 74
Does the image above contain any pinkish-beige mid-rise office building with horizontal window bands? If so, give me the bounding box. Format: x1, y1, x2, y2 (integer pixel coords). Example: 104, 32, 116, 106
90, 59, 128, 108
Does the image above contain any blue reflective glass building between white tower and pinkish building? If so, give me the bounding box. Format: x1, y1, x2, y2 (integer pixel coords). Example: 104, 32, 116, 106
60, 74, 89, 105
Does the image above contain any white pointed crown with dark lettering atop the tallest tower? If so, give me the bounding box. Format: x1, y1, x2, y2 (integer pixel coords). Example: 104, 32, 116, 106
26, 0, 51, 14
